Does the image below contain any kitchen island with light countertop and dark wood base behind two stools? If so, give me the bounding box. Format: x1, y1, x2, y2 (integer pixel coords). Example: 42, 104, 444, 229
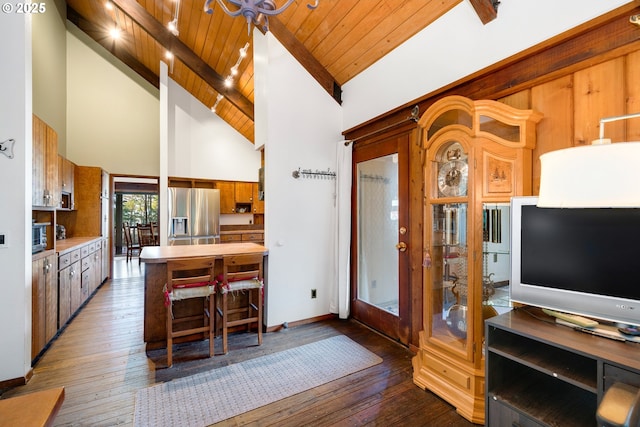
140, 243, 268, 350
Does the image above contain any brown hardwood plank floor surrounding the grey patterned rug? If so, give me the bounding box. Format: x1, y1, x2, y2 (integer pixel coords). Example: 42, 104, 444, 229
1, 258, 473, 427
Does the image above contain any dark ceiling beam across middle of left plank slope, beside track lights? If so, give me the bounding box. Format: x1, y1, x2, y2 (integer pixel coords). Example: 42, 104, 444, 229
111, 0, 254, 120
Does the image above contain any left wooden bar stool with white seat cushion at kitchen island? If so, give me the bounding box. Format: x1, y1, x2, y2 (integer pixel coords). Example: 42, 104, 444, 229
164, 257, 216, 368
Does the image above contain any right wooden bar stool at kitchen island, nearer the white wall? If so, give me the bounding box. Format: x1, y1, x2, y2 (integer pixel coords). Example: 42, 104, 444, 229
216, 254, 264, 354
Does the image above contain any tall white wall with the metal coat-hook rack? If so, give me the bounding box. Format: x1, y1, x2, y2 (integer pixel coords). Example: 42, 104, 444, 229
254, 31, 342, 326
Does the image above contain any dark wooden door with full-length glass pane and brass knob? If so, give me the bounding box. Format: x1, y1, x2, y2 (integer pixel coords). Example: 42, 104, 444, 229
351, 134, 410, 344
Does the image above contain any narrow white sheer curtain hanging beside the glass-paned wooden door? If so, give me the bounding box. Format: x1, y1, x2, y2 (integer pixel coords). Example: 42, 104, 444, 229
329, 141, 353, 319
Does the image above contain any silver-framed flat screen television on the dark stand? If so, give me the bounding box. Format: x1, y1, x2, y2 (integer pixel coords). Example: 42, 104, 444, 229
510, 197, 640, 326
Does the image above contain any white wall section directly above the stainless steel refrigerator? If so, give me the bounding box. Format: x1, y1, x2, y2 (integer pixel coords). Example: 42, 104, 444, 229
168, 79, 260, 182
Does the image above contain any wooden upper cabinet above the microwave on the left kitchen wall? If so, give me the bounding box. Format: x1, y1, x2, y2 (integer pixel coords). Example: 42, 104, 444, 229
31, 115, 60, 207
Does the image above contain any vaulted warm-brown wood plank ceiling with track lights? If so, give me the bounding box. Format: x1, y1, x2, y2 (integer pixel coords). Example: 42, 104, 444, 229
67, 0, 498, 142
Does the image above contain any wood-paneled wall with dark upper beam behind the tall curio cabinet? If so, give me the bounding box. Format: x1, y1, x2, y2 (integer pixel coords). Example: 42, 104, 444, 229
344, 2, 640, 347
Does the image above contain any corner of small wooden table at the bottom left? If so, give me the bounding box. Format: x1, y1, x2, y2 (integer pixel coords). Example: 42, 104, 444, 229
0, 387, 64, 427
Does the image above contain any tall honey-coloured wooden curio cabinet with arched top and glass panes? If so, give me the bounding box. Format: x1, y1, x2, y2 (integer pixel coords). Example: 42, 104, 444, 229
413, 96, 542, 424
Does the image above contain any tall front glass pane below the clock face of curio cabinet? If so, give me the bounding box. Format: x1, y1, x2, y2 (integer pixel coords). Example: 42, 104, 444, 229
430, 203, 469, 351
